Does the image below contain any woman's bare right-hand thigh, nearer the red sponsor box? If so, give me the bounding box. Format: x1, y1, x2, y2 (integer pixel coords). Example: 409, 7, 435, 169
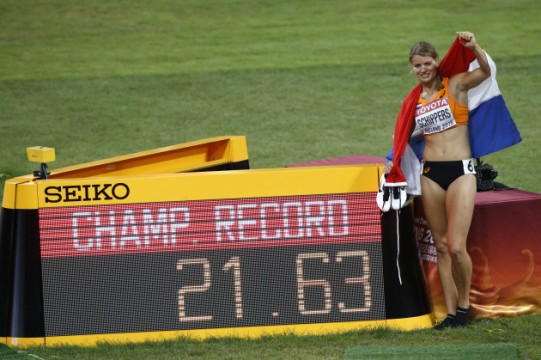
446, 174, 477, 247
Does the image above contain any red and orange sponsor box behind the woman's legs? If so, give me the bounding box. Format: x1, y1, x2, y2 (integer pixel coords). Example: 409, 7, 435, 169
415, 190, 541, 318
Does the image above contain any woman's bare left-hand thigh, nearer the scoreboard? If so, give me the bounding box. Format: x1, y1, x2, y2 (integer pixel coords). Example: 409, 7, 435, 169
421, 176, 447, 243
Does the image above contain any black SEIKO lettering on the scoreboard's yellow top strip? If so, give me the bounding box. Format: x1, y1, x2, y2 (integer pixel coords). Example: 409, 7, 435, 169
45, 183, 130, 203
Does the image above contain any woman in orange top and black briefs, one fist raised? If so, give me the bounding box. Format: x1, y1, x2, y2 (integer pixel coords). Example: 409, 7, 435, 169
384, 31, 490, 330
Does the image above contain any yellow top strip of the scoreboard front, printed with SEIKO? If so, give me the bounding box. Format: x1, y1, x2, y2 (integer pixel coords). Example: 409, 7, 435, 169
36, 165, 378, 207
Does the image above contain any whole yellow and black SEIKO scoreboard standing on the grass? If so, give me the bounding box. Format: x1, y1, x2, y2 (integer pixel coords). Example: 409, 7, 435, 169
0, 137, 432, 347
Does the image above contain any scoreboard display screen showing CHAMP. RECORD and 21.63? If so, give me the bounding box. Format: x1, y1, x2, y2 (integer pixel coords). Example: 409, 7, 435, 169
39, 193, 385, 336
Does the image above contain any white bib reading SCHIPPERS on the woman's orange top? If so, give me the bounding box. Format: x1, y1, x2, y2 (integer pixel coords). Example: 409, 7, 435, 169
415, 96, 456, 135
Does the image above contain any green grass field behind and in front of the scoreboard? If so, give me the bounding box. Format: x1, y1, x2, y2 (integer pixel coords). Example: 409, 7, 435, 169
0, 0, 541, 359
